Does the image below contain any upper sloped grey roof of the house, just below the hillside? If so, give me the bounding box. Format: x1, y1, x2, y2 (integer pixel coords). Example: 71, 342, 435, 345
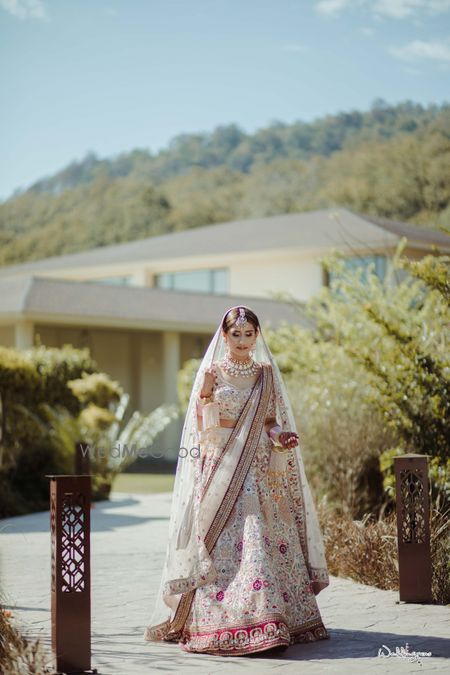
0, 208, 450, 277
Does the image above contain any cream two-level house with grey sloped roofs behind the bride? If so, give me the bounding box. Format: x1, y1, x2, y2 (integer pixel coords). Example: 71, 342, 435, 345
0, 208, 450, 460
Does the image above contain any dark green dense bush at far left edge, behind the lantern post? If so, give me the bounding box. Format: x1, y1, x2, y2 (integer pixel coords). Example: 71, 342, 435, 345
0, 345, 96, 516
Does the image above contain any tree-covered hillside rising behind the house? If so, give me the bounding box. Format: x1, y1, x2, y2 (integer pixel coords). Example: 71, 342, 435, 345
0, 100, 450, 265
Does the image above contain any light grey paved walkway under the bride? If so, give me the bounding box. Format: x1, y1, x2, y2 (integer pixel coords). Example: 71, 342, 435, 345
0, 493, 450, 675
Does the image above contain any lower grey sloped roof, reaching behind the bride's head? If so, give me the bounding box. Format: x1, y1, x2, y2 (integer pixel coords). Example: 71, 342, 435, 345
0, 277, 307, 333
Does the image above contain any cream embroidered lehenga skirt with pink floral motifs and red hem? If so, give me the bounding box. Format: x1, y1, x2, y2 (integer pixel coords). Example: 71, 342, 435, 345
180, 427, 329, 656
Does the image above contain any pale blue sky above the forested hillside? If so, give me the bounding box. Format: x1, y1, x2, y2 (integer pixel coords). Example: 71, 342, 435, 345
0, 0, 450, 199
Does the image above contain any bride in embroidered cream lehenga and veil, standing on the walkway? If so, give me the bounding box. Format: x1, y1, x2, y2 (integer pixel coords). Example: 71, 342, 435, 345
144, 306, 329, 656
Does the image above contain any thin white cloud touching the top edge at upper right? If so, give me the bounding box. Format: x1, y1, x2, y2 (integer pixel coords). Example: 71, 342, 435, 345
314, 0, 450, 19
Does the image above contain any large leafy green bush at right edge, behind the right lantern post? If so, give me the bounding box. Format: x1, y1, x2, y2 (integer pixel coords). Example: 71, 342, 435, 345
284, 240, 450, 510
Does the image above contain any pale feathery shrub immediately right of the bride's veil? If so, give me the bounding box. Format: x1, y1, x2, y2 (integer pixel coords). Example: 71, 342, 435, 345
267, 328, 393, 518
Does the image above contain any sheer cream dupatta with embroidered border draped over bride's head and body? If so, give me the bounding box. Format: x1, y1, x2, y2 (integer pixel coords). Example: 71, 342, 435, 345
144, 305, 329, 641
